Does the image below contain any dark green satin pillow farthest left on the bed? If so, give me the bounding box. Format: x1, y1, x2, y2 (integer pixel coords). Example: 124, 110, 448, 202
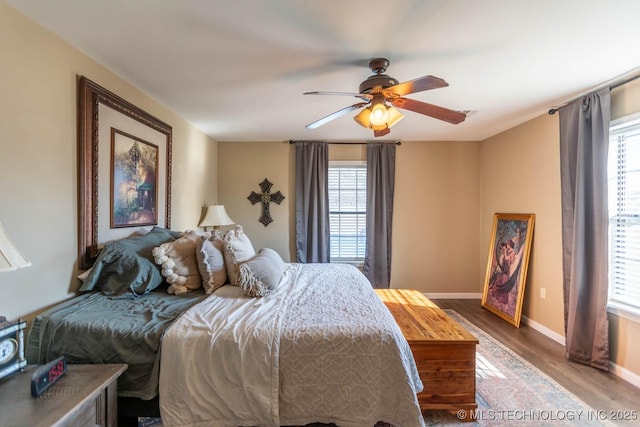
79, 227, 181, 298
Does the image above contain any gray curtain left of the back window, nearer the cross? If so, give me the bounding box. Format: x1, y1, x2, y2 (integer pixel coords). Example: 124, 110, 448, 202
295, 141, 329, 263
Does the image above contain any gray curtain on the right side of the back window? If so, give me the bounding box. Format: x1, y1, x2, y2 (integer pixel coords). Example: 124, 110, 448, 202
363, 143, 396, 288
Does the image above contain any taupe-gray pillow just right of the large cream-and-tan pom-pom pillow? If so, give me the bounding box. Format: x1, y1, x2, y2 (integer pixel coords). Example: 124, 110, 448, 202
196, 232, 227, 294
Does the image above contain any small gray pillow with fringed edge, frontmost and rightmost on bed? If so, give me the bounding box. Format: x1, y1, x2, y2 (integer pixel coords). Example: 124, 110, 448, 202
238, 248, 286, 297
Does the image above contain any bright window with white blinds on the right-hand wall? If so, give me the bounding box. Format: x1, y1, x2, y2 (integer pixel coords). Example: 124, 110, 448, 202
608, 114, 640, 317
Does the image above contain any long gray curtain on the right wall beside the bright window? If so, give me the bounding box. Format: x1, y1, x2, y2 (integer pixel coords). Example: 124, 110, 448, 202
559, 89, 611, 371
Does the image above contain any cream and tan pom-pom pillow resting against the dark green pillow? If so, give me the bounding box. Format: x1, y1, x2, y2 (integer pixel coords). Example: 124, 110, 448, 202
153, 231, 202, 295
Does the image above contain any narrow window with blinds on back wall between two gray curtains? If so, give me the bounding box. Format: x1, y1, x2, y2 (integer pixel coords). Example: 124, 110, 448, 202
329, 161, 367, 262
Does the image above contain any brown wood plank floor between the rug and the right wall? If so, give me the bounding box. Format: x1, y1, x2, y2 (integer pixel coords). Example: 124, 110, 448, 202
433, 299, 640, 425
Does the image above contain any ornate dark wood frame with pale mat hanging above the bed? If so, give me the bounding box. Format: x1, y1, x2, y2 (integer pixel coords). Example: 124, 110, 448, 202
78, 76, 173, 270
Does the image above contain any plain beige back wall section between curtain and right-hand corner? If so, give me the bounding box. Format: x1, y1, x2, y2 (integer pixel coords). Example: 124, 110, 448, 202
391, 141, 482, 295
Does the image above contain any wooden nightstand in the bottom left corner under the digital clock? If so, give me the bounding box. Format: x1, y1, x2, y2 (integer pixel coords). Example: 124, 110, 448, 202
0, 364, 127, 427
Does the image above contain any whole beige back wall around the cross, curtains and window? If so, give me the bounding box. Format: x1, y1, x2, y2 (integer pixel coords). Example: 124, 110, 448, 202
218, 142, 481, 293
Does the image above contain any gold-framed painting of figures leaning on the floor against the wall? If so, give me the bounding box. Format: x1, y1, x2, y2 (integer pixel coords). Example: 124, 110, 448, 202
482, 213, 535, 327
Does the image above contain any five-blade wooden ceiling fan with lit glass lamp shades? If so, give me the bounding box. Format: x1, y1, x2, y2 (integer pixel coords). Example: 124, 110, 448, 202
304, 58, 467, 137
